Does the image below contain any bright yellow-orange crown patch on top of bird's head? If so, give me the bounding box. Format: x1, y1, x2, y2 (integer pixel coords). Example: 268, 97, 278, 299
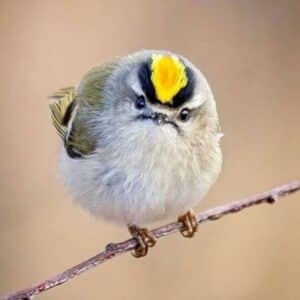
151, 54, 188, 103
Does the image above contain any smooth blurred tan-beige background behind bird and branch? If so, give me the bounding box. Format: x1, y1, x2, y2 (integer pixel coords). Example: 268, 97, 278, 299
0, 0, 300, 300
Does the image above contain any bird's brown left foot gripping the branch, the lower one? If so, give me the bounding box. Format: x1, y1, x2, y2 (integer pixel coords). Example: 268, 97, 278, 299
128, 225, 156, 257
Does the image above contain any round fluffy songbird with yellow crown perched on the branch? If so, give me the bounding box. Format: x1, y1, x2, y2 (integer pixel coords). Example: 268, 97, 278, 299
50, 50, 222, 257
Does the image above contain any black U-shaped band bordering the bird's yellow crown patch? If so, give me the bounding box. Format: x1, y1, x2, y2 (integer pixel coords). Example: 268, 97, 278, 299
138, 62, 195, 108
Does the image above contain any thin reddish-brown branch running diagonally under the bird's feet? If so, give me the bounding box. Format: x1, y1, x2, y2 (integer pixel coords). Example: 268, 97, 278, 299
0, 180, 300, 300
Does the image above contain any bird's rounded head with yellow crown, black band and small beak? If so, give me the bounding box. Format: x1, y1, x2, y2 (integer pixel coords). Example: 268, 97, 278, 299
78, 50, 218, 151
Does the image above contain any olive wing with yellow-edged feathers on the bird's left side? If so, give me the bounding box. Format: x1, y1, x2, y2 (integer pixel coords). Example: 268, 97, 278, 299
50, 61, 117, 158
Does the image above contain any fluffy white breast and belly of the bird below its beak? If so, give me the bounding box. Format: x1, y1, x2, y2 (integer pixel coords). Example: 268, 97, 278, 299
61, 123, 220, 225
